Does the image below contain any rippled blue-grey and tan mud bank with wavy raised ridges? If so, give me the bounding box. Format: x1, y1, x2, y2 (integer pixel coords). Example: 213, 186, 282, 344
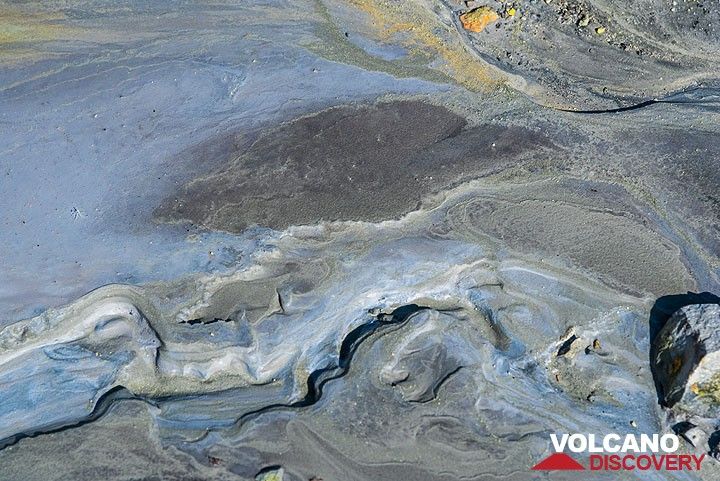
1, 178, 720, 479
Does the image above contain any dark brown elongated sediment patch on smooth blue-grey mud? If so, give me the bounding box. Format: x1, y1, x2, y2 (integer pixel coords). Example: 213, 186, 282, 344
155, 101, 552, 232
